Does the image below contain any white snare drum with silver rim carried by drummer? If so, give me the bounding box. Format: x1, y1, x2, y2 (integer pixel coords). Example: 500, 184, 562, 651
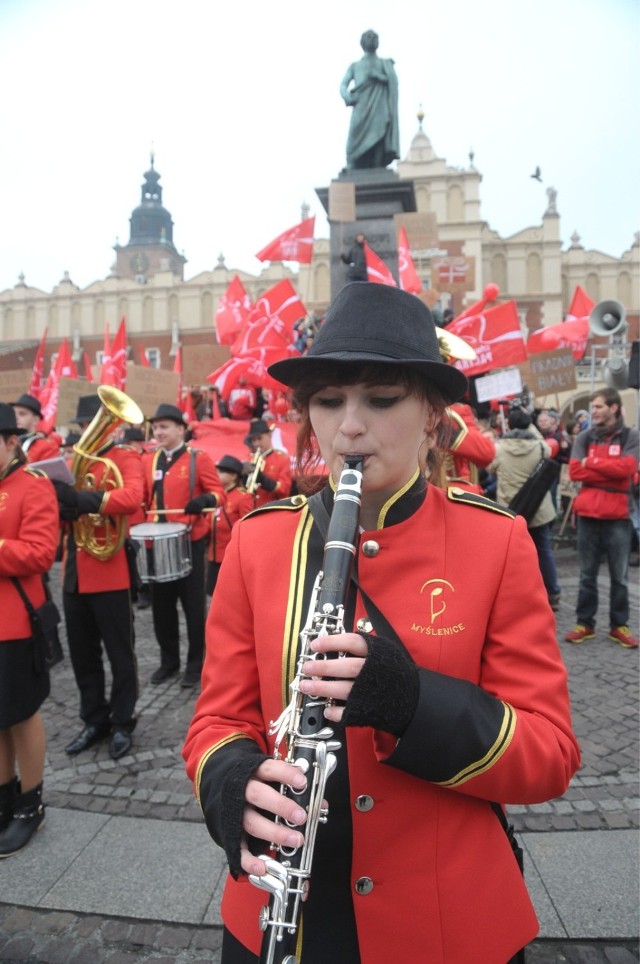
129, 522, 191, 583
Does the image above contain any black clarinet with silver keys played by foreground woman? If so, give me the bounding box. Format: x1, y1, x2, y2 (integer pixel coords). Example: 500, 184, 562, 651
249, 455, 363, 964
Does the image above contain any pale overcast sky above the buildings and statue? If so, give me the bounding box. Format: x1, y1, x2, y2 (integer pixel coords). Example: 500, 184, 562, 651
0, 0, 640, 291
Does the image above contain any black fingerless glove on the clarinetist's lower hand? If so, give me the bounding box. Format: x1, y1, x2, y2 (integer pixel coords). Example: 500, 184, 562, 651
200, 741, 270, 880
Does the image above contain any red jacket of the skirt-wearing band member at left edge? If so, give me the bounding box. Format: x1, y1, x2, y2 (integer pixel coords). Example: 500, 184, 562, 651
0, 466, 59, 640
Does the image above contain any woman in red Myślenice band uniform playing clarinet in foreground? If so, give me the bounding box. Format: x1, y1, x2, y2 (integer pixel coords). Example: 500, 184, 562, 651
183, 283, 579, 964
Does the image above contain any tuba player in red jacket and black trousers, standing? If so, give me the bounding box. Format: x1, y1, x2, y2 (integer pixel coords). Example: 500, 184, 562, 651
54, 395, 142, 760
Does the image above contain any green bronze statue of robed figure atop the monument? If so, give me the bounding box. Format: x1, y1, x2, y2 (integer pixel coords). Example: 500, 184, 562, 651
340, 30, 400, 170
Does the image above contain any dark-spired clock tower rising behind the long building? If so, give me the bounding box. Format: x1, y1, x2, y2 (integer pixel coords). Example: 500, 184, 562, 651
114, 154, 187, 284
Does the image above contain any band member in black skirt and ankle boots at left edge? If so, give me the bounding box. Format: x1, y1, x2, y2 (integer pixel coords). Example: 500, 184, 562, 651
0, 403, 58, 857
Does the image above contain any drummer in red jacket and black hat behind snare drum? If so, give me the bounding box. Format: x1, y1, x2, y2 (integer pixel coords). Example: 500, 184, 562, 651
143, 403, 225, 688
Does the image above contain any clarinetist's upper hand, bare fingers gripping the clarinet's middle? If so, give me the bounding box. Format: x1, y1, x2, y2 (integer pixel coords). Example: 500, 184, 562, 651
300, 633, 369, 723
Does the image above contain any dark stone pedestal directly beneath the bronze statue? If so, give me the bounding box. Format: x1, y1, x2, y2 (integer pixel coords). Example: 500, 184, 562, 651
316, 168, 416, 301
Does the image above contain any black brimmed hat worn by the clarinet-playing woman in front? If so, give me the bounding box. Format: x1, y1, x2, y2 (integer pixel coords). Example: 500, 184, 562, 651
267, 281, 467, 402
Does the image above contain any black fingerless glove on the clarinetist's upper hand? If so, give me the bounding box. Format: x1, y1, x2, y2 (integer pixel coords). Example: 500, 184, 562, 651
342, 633, 420, 737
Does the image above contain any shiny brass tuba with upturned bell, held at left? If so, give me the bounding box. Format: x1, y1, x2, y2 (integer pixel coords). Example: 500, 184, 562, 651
71, 385, 144, 562
